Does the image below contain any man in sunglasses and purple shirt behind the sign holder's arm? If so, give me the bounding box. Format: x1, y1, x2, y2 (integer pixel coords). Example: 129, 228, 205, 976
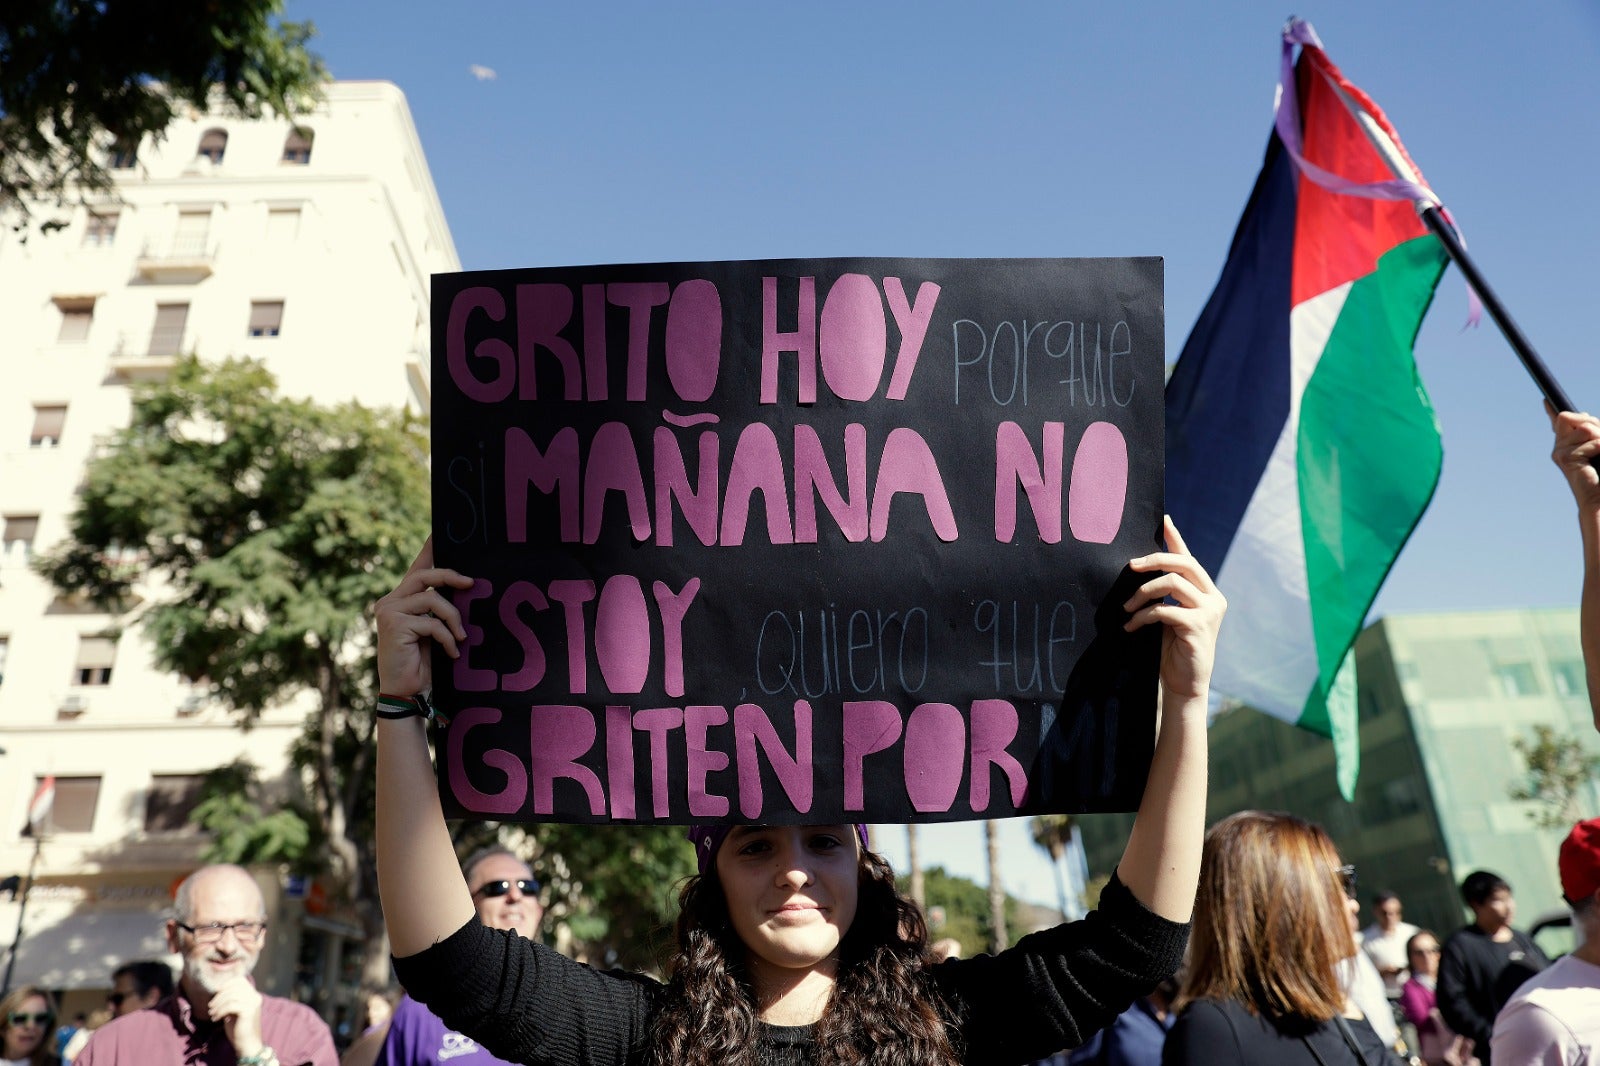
344, 847, 544, 1066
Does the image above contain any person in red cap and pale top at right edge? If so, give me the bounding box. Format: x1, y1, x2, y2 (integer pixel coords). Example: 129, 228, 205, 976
1493, 818, 1600, 1066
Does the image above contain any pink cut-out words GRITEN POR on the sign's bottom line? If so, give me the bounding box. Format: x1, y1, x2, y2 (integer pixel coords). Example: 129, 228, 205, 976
445, 699, 1027, 820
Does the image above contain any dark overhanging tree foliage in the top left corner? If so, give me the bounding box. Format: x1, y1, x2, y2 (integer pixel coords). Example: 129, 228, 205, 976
0, 0, 328, 230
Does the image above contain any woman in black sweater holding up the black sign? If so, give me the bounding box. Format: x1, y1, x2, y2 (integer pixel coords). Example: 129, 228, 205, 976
378, 522, 1226, 1066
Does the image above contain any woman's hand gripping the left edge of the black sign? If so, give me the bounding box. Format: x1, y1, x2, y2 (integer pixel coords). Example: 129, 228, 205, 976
378, 536, 472, 696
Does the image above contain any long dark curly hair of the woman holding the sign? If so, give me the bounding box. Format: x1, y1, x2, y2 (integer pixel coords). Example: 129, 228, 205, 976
653, 852, 960, 1066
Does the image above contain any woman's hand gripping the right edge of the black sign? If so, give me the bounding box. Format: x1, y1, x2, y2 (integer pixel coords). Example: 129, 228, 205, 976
1123, 517, 1227, 699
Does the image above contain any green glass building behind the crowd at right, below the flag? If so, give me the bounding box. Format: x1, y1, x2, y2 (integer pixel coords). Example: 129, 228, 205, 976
1083, 608, 1600, 933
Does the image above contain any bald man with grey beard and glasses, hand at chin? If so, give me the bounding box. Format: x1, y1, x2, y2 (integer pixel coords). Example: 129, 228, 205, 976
74, 866, 339, 1066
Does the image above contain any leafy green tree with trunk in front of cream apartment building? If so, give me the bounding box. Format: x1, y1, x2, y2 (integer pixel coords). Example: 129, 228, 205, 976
35, 359, 429, 968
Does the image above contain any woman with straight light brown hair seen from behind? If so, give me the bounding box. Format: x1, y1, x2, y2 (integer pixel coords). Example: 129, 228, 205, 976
1162, 810, 1400, 1066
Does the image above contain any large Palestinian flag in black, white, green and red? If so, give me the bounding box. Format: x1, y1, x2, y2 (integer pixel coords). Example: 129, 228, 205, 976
1166, 22, 1446, 797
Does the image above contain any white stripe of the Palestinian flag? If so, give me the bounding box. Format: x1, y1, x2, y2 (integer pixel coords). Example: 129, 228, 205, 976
1211, 283, 1350, 722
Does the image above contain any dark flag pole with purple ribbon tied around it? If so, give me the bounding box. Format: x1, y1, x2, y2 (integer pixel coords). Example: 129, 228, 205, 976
1278, 19, 1580, 416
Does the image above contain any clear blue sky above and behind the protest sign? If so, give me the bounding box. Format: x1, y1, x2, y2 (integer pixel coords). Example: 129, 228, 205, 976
288, 0, 1600, 901
